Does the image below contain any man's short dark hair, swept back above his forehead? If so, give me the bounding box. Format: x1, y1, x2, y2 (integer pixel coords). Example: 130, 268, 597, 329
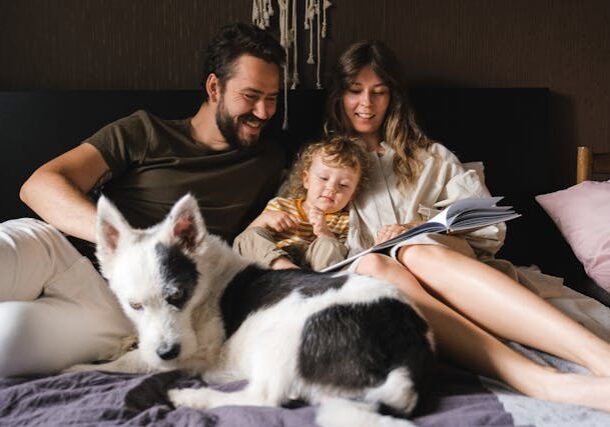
203, 23, 286, 101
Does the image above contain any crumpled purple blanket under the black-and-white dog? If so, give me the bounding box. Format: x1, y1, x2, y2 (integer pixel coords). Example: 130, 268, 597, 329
0, 366, 515, 427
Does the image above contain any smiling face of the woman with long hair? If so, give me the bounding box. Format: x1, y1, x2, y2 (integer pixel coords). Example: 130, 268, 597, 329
343, 65, 390, 148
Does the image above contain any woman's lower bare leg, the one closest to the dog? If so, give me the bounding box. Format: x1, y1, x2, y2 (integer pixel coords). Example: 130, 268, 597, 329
358, 254, 610, 412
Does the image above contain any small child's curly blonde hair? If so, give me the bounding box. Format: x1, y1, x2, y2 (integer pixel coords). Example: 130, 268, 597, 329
282, 136, 369, 199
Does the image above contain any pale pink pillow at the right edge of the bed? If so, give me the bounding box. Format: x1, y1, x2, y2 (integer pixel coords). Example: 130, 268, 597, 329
536, 181, 610, 292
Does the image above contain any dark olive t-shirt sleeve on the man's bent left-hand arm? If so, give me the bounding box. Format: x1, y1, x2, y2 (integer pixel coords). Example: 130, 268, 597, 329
83, 111, 150, 179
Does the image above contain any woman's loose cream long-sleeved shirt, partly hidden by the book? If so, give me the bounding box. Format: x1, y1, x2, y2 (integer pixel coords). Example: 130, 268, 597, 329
347, 143, 506, 258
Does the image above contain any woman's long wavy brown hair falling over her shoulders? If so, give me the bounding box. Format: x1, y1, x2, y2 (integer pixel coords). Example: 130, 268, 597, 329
324, 40, 431, 188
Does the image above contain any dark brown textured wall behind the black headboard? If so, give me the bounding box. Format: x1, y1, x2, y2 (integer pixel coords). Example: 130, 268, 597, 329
0, 0, 610, 187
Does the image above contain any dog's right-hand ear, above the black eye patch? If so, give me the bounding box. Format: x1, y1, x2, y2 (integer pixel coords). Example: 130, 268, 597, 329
167, 194, 207, 252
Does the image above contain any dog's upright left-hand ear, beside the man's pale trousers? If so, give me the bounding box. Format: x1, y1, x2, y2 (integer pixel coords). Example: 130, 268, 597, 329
95, 196, 131, 271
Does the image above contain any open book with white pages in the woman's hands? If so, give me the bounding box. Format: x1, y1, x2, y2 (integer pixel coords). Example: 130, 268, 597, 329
321, 197, 521, 272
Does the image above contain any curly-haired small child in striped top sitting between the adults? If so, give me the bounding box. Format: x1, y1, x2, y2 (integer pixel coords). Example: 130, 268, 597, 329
233, 137, 367, 270
